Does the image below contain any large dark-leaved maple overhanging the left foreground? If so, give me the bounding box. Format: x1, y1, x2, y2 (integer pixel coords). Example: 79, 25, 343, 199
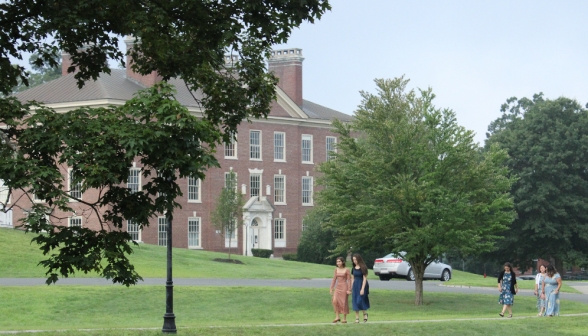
0, 0, 330, 285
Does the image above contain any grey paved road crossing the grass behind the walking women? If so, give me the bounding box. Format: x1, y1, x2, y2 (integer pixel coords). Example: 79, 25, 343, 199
0, 278, 588, 304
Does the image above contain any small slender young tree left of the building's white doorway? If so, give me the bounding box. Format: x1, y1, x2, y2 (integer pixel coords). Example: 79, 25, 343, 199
212, 171, 245, 259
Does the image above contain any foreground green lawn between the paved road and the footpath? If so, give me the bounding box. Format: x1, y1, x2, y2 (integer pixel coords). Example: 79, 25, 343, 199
0, 286, 588, 335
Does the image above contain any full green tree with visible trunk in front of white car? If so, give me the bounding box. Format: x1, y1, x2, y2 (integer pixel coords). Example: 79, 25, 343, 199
317, 78, 513, 305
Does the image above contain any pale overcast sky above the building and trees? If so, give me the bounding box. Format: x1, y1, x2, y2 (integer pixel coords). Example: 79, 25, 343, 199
278, 0, 588, 143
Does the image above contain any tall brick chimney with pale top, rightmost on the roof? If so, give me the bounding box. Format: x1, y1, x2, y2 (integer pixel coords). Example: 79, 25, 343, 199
268, 48, 304, 106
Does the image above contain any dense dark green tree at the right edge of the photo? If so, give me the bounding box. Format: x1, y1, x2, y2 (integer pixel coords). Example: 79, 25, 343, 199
486, 94, 588, 271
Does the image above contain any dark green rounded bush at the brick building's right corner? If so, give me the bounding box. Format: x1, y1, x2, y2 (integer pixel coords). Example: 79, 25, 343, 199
297, 207, 338, 265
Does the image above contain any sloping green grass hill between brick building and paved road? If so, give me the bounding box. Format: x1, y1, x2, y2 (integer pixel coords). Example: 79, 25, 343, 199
0, 229, 334, 279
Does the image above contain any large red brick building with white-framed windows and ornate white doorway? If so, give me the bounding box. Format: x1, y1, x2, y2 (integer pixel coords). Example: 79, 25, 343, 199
6, 40, 351, 256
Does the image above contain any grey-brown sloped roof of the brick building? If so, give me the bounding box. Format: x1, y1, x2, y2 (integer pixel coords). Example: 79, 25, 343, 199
14, 69, 352, 121
